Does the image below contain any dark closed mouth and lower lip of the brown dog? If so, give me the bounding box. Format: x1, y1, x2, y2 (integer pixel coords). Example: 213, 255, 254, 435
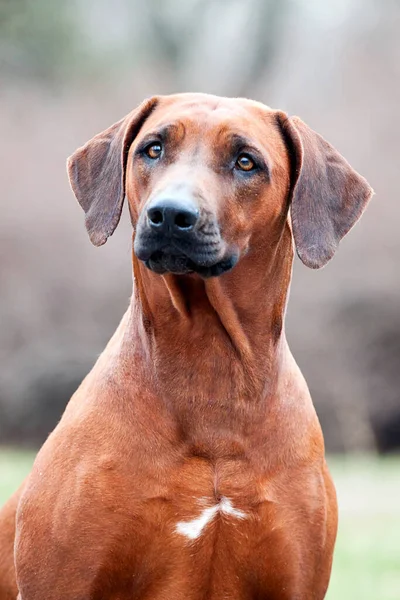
144, 249, 238, 278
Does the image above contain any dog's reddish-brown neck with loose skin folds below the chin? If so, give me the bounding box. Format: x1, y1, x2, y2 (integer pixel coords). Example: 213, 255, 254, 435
125, 225, 293, 412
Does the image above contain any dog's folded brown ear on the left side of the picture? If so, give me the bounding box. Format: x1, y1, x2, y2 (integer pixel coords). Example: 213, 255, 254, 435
67, 98, 158, 246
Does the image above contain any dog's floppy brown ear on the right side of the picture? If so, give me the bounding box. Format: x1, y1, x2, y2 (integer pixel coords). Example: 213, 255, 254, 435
278, 113, 373, 269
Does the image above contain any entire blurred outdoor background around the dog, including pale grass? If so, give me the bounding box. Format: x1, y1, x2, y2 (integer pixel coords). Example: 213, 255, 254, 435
0, 0, 400, 600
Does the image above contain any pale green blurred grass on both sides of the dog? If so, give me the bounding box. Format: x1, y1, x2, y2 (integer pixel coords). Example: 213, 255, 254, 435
0, 450, 400, 600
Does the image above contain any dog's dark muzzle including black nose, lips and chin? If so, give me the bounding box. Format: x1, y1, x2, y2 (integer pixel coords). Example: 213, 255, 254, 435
134, 198, 238, 277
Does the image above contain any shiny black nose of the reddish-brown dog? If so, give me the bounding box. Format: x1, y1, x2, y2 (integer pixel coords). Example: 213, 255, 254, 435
147, 198, 199, 234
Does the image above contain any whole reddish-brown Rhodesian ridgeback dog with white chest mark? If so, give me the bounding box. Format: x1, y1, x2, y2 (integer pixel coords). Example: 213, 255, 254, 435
0, 94, 372, 600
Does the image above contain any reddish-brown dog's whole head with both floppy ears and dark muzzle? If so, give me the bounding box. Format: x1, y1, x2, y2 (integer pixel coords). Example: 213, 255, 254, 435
68, 94, 372, 277
